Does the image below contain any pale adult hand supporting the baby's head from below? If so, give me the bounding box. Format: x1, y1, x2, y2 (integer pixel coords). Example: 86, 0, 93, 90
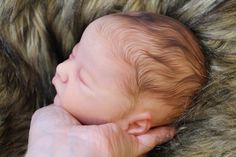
26, 105, 175, 157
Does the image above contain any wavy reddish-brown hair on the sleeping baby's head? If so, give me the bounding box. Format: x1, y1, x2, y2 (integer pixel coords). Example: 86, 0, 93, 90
95, 13, 206, 120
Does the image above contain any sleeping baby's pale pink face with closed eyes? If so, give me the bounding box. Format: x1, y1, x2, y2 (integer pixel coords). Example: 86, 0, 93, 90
52, 19, 129, 124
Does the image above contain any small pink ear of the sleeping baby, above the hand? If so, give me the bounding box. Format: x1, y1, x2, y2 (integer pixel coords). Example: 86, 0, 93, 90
127, 112, 151, 135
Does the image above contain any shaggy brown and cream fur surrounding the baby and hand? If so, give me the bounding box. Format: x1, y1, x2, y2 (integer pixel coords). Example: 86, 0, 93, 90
0, 0, 236, 157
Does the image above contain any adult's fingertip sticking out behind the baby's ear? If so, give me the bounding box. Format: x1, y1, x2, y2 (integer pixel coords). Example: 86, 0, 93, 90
137, 127, 175, 155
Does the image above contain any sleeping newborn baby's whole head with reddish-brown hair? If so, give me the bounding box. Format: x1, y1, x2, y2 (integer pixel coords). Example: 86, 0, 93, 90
52, 12, 206, 135
